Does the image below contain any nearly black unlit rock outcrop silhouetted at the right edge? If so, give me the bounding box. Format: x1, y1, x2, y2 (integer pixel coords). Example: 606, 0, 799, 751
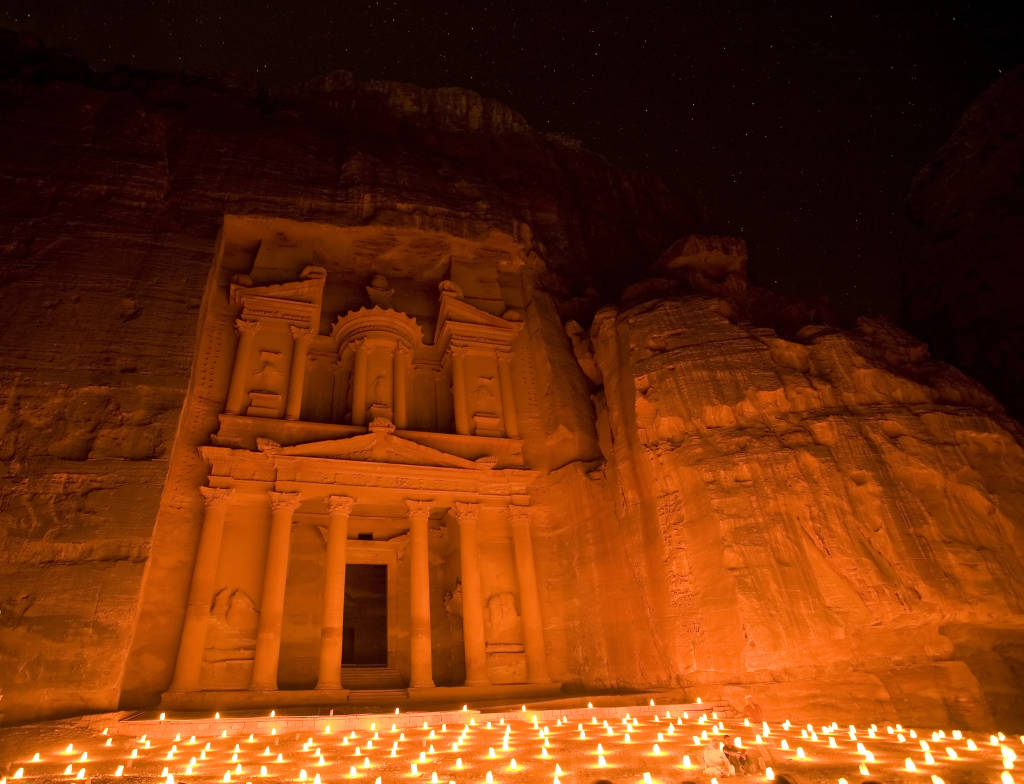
903, 67, 1024, 418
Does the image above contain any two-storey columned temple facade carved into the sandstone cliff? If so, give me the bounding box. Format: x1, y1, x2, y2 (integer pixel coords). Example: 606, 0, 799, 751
153, 223, 559, 708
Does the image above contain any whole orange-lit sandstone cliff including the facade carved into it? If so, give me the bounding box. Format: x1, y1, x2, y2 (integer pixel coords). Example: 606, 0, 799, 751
0, 30, 1024, 726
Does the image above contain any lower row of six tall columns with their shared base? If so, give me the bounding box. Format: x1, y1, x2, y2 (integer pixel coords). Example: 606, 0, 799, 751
162, 478, 560, 709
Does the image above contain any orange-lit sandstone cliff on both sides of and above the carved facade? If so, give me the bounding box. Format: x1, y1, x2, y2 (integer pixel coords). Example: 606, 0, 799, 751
0, 30, 1024, 726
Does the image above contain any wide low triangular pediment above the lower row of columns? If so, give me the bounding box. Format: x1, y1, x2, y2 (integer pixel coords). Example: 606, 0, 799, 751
273, 432, 493, 471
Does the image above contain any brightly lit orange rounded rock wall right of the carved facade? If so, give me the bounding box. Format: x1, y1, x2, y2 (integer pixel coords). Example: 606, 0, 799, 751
580, 295, 1024, 726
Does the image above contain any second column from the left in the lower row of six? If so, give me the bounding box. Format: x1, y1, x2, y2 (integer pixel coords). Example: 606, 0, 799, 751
250, 492, 300, 691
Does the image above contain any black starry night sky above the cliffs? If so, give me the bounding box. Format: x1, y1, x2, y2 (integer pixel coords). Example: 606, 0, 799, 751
0, 0, 1024, 315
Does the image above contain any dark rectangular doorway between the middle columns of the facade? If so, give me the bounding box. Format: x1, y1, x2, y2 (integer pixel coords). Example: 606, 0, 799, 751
341, 564, 387, 667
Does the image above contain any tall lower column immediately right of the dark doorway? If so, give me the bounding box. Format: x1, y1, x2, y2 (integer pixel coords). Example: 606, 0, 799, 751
406, 500, 434, 689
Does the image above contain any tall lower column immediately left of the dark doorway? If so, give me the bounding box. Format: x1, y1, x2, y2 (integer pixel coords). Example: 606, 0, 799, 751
316, 495, 355, 689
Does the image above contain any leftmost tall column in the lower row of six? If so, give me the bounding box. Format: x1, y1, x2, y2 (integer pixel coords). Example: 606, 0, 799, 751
171, 487, 231, 692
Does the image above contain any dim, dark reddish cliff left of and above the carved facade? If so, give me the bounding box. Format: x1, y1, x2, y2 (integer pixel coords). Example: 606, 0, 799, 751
0, 34, 695, 723
